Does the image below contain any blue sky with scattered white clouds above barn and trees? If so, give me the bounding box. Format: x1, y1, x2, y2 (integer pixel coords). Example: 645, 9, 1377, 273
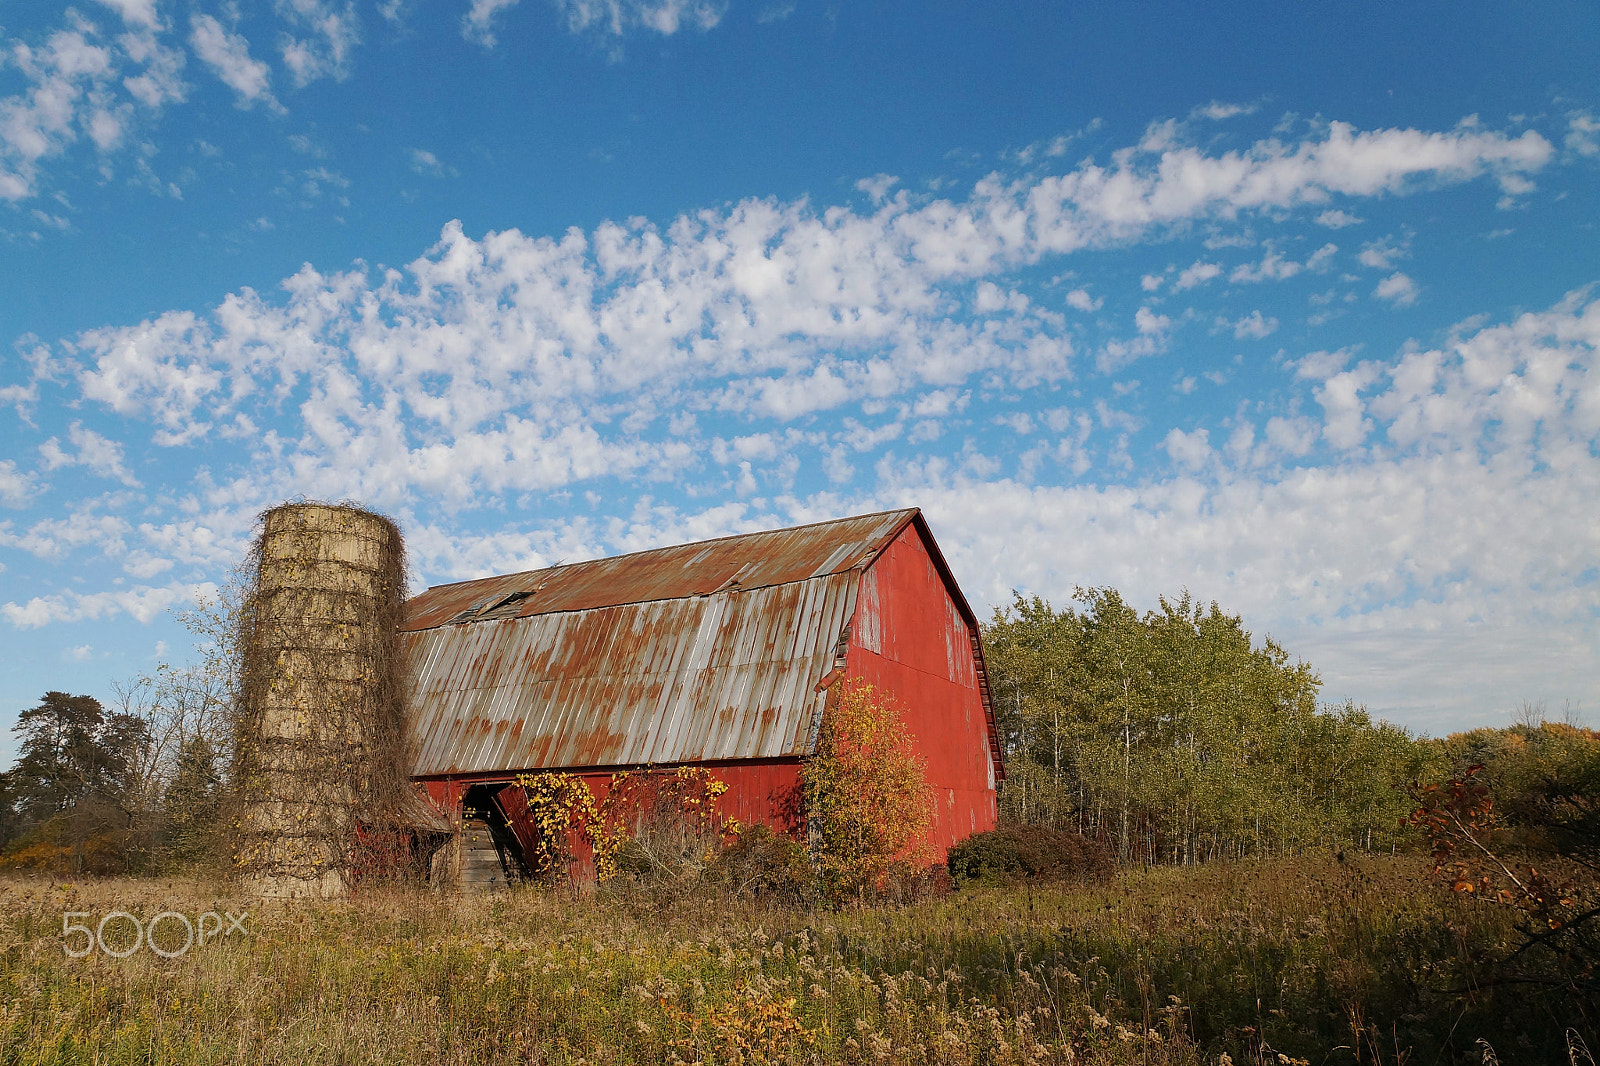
0, 0, 1600, 752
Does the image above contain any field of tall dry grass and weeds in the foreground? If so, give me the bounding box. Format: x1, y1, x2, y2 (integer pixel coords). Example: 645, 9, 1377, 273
0, 856, 1582, 1066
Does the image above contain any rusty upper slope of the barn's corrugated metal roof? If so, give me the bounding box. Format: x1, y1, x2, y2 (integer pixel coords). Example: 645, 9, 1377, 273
405, 507, 918, 631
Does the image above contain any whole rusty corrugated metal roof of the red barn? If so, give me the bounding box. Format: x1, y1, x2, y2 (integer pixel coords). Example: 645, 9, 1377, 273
403, 509, 976, 776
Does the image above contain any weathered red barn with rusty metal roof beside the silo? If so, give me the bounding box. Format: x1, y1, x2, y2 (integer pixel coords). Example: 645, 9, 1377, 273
405, 509, 1005, 882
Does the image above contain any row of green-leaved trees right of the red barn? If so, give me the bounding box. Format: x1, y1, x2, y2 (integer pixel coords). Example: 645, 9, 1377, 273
984, 589, 1448, 864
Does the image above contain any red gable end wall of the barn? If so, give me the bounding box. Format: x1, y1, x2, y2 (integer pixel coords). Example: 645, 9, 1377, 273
845, 525, 998, 860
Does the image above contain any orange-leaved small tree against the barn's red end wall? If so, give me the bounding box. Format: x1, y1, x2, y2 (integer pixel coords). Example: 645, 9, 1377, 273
802, 677, 933, 901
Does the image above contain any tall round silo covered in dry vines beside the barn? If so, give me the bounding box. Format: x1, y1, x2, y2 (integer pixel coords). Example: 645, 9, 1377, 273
235, 503, 408, 896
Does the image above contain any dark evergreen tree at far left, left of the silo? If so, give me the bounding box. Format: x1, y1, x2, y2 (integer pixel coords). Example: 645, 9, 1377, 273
6, 691, 149, 872
